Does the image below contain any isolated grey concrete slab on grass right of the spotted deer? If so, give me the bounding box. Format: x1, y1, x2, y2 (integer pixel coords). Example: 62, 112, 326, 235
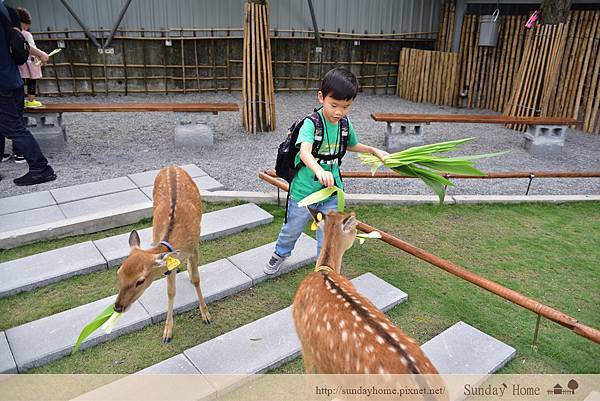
422, 322, 517, 374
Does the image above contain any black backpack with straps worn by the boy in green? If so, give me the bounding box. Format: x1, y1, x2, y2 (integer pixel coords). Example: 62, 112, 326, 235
275, 109, 349, 183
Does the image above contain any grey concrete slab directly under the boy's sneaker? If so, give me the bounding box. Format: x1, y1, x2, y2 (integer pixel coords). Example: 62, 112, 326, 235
227, 233, 317, 284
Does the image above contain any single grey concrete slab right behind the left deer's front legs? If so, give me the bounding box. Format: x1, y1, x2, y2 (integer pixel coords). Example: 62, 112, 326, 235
138, 259, 252, 324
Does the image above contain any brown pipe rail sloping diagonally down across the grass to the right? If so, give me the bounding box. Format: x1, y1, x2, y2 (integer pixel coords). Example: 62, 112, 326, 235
258, 172, 600, 344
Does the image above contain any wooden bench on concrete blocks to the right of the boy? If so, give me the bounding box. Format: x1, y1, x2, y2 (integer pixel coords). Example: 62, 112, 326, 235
371, 113, 577, 157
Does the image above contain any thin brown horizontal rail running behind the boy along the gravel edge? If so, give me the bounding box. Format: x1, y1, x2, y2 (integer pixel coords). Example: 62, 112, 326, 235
265, 169, 600, 180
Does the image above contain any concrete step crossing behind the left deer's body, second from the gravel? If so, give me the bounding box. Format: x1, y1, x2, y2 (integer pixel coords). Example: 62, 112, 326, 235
0, 203, 273, 298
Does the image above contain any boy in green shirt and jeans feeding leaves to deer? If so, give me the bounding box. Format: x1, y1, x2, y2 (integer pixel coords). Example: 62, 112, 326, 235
263, 67, 387, 274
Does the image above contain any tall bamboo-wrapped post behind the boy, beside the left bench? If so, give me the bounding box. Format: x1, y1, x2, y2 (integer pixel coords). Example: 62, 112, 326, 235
242, 1, 275, 133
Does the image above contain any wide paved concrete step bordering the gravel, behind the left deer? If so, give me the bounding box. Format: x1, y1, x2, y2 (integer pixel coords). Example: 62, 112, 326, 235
0, 164, 223, 249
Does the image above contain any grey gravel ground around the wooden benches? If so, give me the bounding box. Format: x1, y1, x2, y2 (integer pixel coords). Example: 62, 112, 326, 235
0, 93, 600, 197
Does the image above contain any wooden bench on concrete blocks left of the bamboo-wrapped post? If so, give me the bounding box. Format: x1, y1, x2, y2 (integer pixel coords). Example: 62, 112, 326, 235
24, 103, 239, 151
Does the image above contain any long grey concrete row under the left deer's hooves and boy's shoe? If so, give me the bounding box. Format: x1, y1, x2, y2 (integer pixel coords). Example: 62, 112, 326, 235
0, 234, 316, 373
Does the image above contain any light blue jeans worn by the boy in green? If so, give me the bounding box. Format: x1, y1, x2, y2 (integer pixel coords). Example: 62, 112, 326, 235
275, 196, 337, 258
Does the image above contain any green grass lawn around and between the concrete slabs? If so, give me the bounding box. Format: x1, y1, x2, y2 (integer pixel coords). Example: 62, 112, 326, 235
0, 203, 600, 373
